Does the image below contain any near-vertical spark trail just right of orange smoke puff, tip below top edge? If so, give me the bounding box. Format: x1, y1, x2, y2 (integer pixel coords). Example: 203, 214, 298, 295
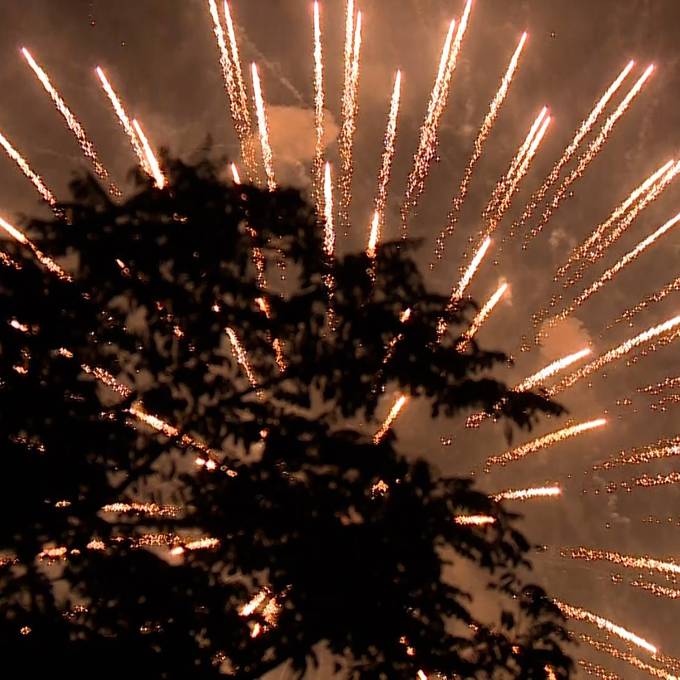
338, 7, 362, 236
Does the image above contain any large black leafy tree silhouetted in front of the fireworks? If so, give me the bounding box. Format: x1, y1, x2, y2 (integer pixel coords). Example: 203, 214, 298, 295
0, 157, 571, 680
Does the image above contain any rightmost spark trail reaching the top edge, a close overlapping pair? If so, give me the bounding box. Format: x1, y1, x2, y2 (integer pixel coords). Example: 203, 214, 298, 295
401, 0, 472, 238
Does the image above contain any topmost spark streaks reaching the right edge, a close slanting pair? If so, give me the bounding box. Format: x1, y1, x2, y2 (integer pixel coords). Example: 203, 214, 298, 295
557, 160, 680, 287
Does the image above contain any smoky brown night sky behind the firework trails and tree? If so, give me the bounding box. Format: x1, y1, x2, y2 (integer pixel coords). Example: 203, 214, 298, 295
0, 0, 680, 678
